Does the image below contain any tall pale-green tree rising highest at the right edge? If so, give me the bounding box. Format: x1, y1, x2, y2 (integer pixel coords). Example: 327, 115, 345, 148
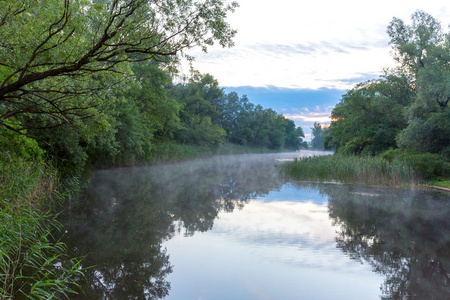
388, 11, 450, 156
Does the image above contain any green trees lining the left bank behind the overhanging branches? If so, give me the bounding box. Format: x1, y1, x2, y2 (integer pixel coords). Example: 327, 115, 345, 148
0, 61, 307, 169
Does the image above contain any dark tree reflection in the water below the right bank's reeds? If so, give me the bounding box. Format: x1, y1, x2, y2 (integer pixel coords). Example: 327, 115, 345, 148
292, 185, 450, 300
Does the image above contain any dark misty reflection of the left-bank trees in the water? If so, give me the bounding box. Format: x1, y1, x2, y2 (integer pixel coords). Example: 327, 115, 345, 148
63, 156, 282, 299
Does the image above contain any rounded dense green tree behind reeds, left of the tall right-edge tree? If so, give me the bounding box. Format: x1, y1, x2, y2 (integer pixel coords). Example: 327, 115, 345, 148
325, 75, 413, 155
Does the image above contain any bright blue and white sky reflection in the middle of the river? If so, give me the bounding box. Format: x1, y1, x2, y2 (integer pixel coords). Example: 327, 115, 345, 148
164, 185, 382, 300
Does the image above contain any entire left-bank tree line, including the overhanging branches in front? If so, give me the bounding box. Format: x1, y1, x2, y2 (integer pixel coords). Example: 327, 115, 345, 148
0, 0, 304, 173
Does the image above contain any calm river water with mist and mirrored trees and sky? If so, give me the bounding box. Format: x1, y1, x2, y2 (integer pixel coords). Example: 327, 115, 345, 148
63, 151, 450, 300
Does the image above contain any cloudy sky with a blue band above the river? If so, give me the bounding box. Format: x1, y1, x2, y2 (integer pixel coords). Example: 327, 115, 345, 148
182, 0, 450, 138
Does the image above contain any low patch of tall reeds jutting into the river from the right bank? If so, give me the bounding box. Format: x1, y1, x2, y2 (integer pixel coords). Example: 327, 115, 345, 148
281, 154, 421, 187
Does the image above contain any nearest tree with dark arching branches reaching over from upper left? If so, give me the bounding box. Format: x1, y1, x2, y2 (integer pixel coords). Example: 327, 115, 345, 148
0, 0, 237, 132
